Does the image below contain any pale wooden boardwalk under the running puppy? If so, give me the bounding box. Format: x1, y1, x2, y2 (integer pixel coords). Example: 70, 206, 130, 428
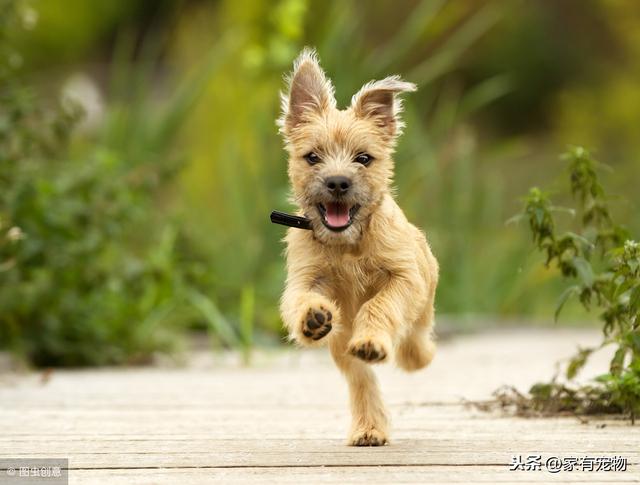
0, 329, 640, 484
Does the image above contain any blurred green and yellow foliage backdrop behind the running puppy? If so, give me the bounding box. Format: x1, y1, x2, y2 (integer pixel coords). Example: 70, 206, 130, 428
0, 0, 640, 366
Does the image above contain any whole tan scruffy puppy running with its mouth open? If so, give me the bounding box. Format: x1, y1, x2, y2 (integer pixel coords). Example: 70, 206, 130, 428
278, 49, 438, 446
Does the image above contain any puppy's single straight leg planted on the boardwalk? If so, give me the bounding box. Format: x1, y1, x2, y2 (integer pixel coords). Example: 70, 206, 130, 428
330, 335, 388, 446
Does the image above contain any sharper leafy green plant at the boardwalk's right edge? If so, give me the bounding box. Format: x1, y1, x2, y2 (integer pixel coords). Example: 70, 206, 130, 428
501, 147, 640, 421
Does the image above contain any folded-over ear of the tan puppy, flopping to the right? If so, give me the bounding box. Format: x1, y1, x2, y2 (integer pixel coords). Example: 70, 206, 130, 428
351, 76, 417, 138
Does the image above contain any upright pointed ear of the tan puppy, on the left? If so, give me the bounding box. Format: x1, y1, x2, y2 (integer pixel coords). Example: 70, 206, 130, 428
278, 48, 336, 136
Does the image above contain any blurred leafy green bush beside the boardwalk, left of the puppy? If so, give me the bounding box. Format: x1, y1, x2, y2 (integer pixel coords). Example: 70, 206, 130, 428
0, 81, 185, 365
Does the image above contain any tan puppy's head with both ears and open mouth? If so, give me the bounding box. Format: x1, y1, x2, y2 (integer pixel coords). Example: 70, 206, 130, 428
278, 49, 416, 244
